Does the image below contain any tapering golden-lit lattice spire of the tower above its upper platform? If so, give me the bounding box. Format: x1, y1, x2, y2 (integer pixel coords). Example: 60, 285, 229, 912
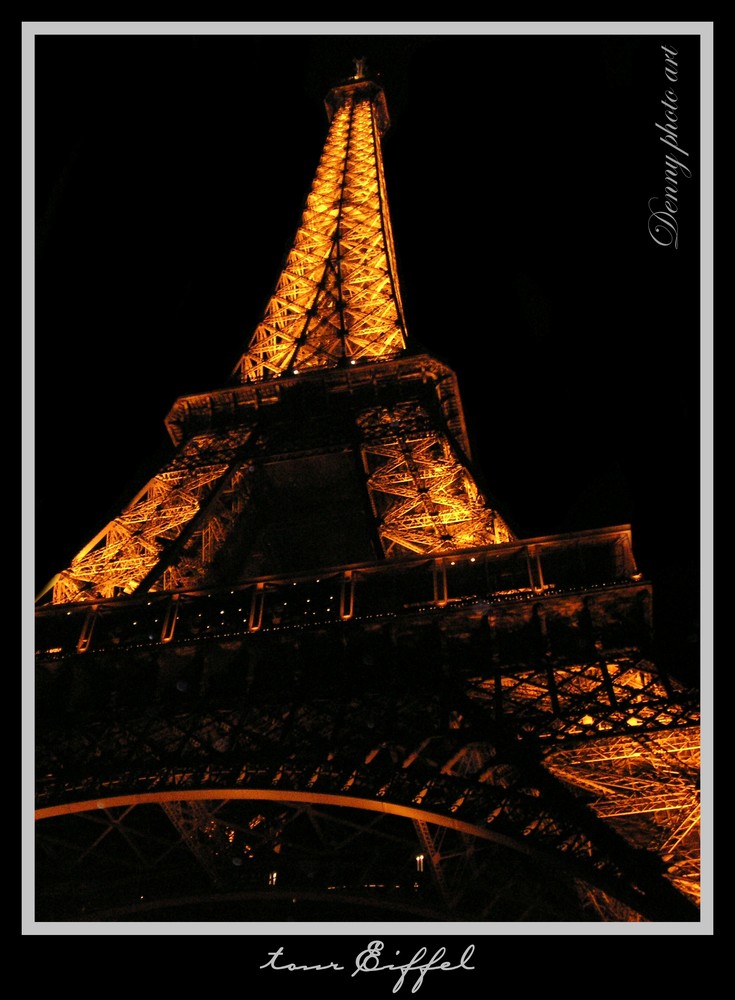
233, 59, 406, 382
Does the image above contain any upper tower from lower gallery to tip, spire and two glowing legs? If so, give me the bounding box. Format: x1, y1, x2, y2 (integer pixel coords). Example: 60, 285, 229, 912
39, 72, 513, 604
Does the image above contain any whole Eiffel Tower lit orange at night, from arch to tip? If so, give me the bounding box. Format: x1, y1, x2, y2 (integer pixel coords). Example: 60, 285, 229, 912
35, 61, 699, 923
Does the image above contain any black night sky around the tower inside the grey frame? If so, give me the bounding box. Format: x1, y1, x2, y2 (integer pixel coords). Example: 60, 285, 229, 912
32, 26, 703, 688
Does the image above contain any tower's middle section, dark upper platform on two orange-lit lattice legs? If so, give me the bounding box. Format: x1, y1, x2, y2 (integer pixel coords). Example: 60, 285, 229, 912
39, 358, 511, 604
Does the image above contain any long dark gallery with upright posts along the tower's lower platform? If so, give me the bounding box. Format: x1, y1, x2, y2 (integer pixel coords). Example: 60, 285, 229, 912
35, 527, 641, 659
